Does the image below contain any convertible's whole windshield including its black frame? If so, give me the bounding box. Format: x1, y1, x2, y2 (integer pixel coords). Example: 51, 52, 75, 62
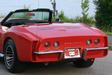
1, 9, 52, 27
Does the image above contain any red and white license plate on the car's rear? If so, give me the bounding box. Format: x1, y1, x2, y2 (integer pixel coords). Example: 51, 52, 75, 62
64, 49, 80, 59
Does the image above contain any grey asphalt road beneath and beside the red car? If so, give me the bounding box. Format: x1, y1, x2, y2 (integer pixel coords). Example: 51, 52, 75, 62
0, 52, 112, 75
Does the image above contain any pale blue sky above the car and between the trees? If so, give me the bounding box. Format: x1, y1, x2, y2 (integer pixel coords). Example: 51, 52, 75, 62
0, 0, 95, 18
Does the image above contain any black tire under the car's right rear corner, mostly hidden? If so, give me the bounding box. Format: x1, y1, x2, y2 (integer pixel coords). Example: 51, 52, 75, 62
73, 59, 95, 68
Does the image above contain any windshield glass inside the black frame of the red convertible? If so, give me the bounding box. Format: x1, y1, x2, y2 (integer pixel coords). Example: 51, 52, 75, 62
7, 11, 49, 22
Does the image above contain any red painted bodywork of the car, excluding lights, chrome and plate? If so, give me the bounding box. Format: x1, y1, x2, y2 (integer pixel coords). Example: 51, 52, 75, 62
0, 23, 108, 62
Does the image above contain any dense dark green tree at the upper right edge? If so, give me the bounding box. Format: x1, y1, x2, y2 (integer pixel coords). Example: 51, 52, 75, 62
94, 0, 112, 32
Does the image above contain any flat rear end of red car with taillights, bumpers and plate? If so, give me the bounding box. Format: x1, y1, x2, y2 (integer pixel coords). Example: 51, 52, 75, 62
33, 36, 108, 62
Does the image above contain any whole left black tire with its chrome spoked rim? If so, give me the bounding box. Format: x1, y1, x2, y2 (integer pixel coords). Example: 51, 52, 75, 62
4, 39, 24, 73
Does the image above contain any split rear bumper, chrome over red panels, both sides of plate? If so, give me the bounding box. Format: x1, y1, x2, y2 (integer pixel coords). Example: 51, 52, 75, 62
33, 47, 108, 62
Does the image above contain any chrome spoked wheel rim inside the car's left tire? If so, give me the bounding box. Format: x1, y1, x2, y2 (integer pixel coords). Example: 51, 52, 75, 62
5, 45, 14, 68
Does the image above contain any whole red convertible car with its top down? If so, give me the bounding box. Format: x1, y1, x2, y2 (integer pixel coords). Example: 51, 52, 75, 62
0, 8, 108, 73
